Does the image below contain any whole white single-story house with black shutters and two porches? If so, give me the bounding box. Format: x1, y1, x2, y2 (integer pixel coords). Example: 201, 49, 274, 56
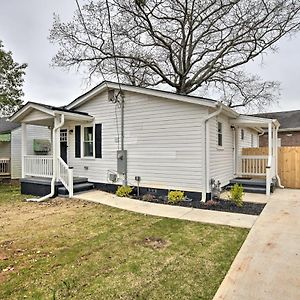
11, 82, 279, 200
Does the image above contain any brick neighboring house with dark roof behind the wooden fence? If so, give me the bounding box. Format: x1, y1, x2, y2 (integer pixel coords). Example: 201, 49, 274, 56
255, 110, 300, 147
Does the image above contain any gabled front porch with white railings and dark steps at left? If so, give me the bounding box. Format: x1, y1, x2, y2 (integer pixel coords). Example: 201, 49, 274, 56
11, 103, 93, 198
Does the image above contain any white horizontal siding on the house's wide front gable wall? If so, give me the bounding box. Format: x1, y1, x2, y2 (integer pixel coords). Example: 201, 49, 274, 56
68, 92, 208, 191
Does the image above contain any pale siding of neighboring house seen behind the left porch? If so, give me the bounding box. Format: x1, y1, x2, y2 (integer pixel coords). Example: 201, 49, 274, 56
11, 125, 51, 179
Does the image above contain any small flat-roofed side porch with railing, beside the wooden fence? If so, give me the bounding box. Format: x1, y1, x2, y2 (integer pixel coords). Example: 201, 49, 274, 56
230, 116, 281, 195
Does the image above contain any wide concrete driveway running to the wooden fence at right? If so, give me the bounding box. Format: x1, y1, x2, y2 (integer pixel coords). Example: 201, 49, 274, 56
214, 189, 300, 300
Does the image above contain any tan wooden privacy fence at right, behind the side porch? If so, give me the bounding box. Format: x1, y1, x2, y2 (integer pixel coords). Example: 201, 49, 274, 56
242, 147, 300, 189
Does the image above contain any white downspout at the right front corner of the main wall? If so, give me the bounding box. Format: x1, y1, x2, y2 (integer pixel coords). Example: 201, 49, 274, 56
202, 103, 223, 202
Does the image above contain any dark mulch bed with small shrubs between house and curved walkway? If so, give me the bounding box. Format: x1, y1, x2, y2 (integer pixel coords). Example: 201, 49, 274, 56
132, 196, 266, 216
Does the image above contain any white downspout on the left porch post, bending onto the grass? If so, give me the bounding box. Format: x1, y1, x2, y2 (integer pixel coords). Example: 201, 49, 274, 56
26, 114, 65, 202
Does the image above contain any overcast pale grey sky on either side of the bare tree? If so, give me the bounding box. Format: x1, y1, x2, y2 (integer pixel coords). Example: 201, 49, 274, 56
0, 0, 300, 111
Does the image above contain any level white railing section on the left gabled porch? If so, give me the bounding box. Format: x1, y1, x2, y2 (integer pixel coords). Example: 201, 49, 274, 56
24, 155, 53, 178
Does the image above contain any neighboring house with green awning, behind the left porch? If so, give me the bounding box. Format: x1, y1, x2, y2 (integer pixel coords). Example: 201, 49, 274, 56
0, 117, 50, 179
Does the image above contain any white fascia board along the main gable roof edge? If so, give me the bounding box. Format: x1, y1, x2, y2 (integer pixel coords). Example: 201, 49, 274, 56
66, 82, 219, 111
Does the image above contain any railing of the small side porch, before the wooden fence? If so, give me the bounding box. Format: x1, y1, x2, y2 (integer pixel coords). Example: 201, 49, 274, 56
240, 155, 268, 176
